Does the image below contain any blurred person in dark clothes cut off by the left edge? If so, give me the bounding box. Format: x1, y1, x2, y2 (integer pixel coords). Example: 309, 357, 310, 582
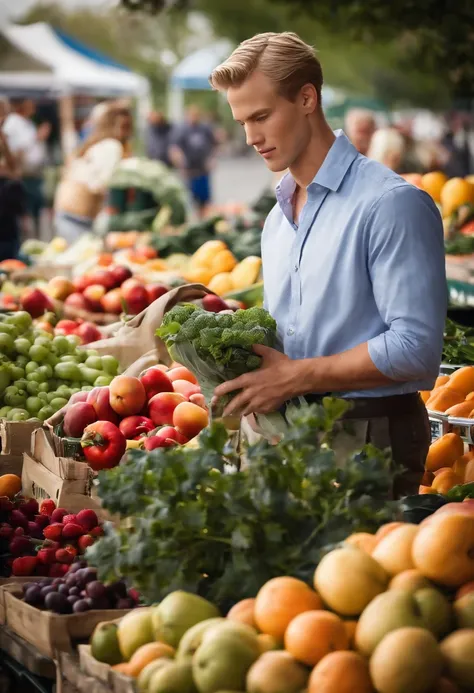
0, 98, 26, 261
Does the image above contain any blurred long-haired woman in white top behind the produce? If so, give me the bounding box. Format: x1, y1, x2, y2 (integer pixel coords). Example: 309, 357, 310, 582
54, 104, 133, 244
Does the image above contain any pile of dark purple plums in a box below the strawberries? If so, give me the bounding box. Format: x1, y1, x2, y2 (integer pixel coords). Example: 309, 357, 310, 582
22, 561, 138, 614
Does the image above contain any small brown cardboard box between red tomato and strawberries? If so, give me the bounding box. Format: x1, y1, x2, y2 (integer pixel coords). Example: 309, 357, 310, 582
21, 453, 104, 517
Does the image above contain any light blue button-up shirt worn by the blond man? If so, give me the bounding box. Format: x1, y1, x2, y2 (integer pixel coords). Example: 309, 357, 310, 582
262, 130, 447, 397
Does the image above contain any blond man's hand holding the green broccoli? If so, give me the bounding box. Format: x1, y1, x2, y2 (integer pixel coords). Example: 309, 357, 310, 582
214, 344, 304, 416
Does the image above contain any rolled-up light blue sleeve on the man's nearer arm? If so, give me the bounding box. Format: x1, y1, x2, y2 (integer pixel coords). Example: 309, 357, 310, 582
366, 185, 448, 381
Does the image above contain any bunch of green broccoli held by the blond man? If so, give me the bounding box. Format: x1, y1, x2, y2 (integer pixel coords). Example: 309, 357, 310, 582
156, 304, 277, 402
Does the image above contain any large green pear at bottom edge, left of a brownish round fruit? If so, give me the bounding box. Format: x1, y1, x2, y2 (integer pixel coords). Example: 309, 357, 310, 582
192, 628, 259, 693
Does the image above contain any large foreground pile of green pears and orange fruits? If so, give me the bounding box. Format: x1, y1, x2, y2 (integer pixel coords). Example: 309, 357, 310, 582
91, 503, 474, 693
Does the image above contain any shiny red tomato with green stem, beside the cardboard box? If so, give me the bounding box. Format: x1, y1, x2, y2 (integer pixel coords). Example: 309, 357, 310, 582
81, 421, 127, 472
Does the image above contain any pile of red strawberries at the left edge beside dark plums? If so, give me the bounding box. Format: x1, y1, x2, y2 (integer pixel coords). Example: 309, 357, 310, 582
0, 486, 103, 577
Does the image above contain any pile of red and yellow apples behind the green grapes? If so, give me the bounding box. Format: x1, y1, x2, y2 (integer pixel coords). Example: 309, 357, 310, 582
46, 265, 169, 315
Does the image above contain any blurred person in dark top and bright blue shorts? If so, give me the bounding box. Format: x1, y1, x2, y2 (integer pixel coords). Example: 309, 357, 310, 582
169, 106, 219, 218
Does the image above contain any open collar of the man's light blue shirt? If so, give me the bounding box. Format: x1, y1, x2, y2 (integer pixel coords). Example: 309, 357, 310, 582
276, 130, 358, 204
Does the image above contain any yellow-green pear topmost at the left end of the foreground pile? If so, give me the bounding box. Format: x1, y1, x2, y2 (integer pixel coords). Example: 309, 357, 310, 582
152, 590, 220, 648
